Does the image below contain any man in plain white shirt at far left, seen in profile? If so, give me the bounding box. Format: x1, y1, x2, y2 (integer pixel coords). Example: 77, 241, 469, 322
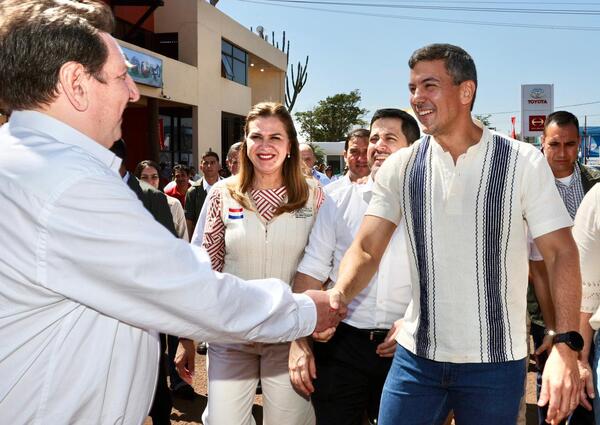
0, 0, 337, 425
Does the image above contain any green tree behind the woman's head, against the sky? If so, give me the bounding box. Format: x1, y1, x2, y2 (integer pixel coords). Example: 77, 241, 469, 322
295, 90, 368, 142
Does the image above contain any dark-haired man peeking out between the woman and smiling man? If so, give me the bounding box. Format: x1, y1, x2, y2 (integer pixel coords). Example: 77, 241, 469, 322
324, 128, 370, 194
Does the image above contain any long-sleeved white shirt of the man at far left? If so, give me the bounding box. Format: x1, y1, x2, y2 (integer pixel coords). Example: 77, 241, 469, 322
0, 111, 316, 425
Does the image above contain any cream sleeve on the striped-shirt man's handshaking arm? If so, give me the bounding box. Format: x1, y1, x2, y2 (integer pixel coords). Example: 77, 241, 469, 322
365, 149, 407, 226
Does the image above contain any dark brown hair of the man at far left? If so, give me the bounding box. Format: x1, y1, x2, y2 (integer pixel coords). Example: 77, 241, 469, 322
0, 0, 114, 111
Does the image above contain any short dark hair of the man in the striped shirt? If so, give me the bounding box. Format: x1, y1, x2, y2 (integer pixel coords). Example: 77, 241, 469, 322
408, 43, 477, 111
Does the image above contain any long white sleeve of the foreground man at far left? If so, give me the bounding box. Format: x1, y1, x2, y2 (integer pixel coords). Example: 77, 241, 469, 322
44, 175, 316, 342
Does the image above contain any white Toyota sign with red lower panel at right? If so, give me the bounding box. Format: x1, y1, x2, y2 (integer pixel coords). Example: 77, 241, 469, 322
521, 84, 554, 137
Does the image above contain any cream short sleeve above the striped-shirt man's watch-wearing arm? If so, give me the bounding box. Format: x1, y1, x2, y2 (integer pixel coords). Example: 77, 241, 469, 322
521, 146, 573, 239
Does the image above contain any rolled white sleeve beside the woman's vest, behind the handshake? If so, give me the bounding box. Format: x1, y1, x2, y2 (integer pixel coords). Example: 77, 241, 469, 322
298, 196, 336, 282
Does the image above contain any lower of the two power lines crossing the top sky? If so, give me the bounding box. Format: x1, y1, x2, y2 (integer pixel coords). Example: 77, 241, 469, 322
238, 0, 600, 32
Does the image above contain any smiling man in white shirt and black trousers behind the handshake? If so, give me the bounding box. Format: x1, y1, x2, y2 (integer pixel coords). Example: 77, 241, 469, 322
289, 109, 419, 425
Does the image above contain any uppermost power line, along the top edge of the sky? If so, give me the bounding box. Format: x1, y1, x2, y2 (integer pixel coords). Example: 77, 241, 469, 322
265, 0, 600, 16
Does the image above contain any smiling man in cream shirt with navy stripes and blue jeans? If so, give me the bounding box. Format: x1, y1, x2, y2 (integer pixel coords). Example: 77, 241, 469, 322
331, 44, 581, 425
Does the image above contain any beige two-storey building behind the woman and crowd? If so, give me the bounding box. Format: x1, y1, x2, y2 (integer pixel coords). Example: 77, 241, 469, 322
104, 0, 287, 169
